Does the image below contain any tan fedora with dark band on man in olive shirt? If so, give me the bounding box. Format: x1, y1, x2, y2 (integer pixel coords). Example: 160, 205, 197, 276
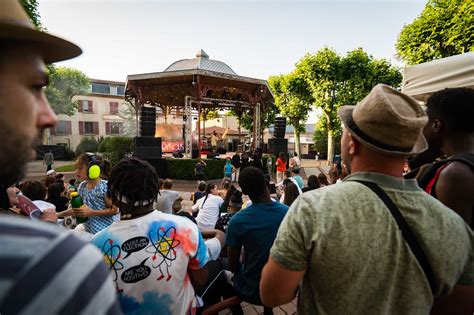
339, 84, 428, 156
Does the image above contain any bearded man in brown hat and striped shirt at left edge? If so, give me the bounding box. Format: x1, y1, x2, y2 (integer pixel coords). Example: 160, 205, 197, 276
0, 0, 121, 314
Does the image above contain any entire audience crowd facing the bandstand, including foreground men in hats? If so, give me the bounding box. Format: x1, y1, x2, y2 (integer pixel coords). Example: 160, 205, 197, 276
0, 0, 474, 315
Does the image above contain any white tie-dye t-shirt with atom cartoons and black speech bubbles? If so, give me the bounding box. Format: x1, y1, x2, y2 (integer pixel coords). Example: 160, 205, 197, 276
91, 211, 208, 315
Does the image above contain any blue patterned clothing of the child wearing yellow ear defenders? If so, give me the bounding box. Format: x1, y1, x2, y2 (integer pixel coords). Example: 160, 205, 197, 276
77, 180, 120, 234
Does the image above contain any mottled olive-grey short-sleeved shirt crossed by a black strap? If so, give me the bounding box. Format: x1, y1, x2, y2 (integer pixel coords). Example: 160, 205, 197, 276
270, 173, 474, 314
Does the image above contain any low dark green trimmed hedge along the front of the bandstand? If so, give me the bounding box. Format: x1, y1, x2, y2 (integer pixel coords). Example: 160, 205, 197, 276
166, 159, 225, 180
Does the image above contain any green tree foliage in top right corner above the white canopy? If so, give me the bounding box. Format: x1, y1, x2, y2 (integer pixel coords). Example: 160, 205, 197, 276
395, 0, 474, 65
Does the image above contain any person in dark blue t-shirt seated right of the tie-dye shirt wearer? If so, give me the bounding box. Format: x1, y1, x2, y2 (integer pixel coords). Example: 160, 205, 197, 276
226, 166, 288, 314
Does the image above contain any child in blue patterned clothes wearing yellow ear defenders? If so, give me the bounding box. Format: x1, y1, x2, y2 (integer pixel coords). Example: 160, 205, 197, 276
73, 153, 120, 234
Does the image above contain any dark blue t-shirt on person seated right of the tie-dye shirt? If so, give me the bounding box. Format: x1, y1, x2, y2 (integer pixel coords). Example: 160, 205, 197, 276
225, 202, 288, 305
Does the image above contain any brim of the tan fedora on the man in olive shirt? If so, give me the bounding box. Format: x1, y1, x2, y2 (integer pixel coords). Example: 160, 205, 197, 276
338, 105, 428, 156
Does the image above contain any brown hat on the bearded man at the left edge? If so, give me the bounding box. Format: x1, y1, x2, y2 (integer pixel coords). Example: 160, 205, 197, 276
0, 0, 82, 64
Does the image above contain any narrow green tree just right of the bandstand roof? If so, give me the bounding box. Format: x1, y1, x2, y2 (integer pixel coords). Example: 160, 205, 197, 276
268, 72, 313, 154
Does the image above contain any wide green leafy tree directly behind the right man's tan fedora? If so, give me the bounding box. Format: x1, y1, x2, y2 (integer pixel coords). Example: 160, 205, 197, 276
296, 47, 402, 163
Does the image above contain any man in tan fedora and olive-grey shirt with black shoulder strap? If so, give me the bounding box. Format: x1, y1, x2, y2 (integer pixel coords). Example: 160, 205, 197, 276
260, 84, 474, 314
